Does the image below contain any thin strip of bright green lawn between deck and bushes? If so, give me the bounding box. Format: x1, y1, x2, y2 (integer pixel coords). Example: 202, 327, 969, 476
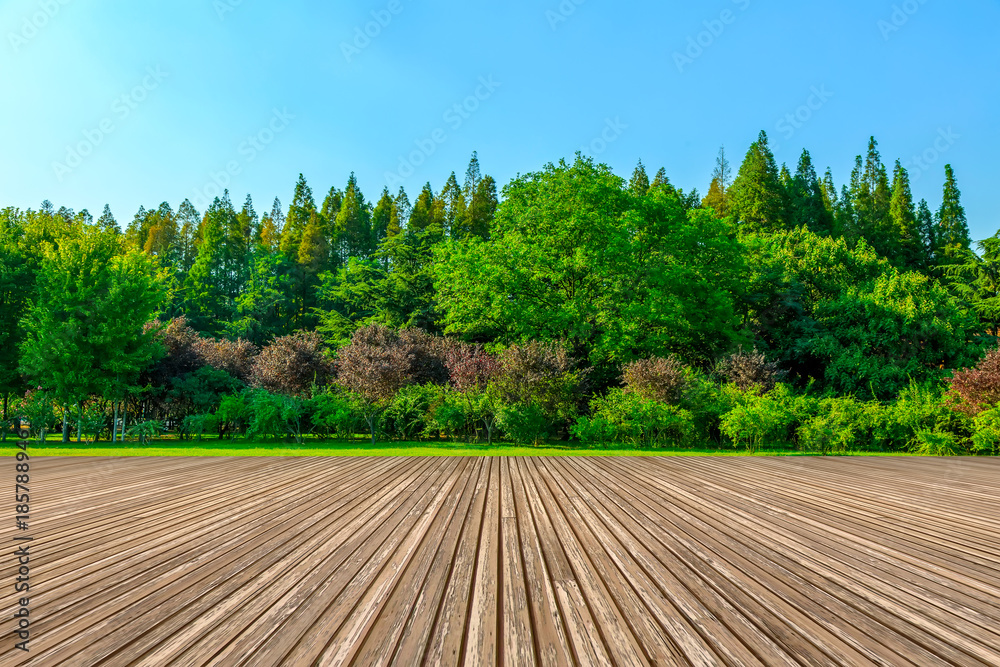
0, 439, 920, 456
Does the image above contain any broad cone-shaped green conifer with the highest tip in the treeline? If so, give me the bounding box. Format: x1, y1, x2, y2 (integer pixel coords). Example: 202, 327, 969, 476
730, 131, 785, 232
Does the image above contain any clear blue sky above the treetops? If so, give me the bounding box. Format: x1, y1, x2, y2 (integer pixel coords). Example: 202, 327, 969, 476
0, 0, 1000, 239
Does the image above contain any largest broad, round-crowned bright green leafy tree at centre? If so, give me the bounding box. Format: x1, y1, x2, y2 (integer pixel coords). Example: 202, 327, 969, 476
435, 156, 741, 376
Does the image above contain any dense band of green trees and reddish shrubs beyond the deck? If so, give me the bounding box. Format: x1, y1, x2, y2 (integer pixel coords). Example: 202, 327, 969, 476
0, 132, 1000, 454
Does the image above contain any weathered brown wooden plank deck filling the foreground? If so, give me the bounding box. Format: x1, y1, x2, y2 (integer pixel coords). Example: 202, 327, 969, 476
0, 458, 1000, 666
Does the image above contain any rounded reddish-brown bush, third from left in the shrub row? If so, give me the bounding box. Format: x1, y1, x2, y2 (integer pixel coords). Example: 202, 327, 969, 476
250, 332, 333, 396
